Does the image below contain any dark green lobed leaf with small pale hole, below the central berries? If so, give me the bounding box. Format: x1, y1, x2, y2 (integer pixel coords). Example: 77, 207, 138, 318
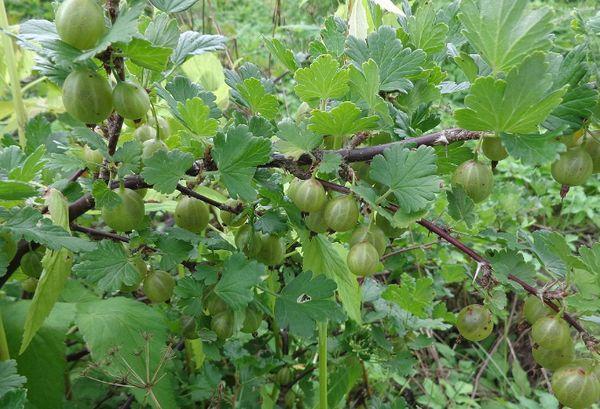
275, 271, 344, 338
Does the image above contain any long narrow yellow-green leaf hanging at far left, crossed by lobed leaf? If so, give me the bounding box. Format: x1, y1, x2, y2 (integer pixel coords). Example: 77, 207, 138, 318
19, 189, 73, 354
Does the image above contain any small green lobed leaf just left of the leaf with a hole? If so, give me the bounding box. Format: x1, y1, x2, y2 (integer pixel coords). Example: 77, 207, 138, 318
214, 253, 266, 310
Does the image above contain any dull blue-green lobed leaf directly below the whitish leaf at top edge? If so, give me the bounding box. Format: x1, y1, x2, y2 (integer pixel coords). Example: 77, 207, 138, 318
346, 26, 427, 92
